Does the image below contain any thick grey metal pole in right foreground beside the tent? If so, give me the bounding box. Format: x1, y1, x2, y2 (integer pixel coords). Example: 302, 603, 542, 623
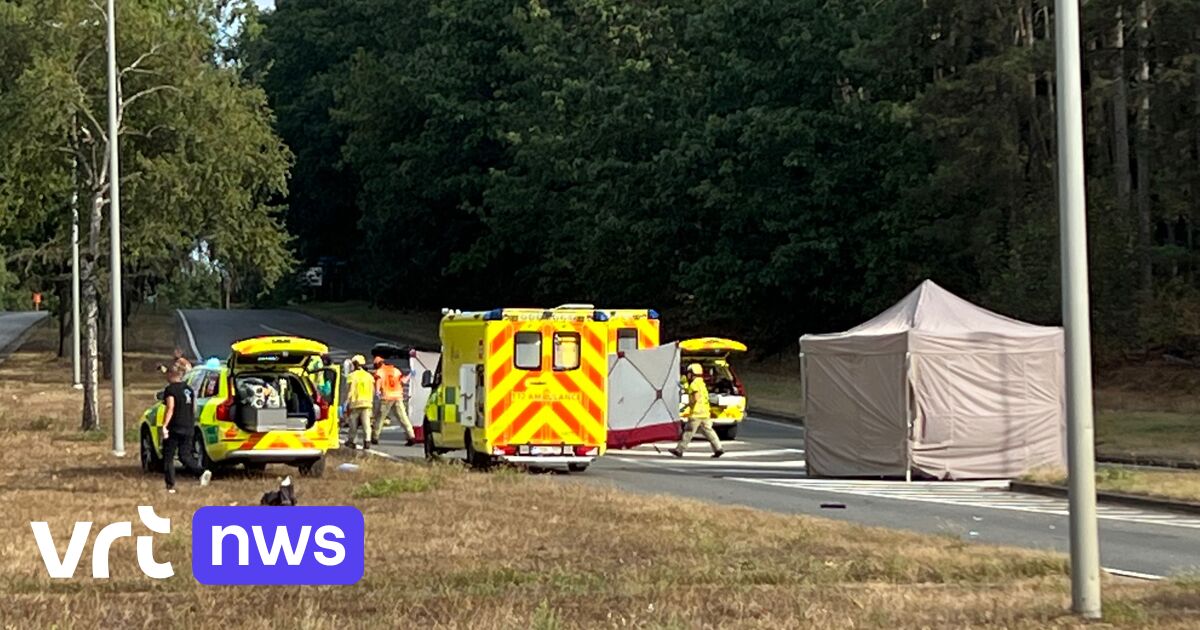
1055, 0, 1100, 619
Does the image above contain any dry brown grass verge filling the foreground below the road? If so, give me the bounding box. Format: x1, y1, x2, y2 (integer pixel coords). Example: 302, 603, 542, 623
0, 312, 1200, 629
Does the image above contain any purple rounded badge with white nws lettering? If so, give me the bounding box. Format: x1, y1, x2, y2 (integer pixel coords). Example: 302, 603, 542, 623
192, 505, 366, 584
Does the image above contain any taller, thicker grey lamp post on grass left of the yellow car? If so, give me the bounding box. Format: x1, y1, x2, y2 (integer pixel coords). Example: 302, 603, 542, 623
108, 0, 125, 457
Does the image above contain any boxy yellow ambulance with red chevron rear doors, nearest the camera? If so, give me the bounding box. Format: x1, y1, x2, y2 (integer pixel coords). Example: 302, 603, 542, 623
421, 305, 608, 472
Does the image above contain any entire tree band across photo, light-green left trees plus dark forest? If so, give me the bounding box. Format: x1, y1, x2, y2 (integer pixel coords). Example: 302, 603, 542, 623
7, 0, 1200, 353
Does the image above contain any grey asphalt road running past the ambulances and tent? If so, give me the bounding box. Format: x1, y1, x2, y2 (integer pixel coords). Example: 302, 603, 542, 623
184, 311, 1200, 576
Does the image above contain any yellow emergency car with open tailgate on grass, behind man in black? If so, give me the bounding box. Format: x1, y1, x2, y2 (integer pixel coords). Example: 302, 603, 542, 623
139, 337, 341, 476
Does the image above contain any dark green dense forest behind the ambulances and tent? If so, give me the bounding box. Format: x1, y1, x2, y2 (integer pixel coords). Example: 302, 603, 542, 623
240, 0, 1200, 349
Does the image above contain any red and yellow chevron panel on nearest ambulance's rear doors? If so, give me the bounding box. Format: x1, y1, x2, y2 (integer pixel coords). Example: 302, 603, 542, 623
485, 322, 607, 445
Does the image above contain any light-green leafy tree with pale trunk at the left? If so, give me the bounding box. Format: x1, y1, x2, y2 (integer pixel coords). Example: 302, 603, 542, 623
0, 0, 292, 430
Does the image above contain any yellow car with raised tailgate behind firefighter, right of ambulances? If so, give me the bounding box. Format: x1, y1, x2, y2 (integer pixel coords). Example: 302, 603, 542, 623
679, 337, 746, 439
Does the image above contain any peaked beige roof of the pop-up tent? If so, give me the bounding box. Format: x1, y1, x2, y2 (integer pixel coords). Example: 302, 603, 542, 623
803, 280, 1062, 340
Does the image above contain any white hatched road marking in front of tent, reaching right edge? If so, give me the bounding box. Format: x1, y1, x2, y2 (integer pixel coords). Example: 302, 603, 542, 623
726, 476, 1200, 529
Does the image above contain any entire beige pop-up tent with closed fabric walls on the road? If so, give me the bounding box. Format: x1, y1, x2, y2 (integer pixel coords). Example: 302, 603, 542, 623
800, 280, 1066, 479
